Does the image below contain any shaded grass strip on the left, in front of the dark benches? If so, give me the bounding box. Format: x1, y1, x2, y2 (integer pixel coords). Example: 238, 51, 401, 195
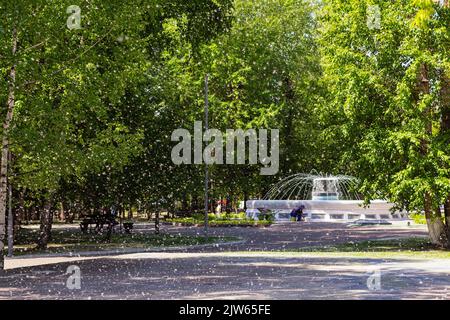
7, 228, 239, 255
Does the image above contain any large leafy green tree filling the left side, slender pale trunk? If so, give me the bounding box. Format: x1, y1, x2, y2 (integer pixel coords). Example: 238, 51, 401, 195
0, 0, 231, 269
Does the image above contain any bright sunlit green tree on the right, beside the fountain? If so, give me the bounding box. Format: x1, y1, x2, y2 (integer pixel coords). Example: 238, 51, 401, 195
321, 0, 450, 247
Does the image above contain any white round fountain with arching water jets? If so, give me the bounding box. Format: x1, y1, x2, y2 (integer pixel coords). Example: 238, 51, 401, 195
246, 174, 408, 222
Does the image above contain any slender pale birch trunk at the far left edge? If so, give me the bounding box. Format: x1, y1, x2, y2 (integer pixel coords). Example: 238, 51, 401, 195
0, 27, 17, 270
